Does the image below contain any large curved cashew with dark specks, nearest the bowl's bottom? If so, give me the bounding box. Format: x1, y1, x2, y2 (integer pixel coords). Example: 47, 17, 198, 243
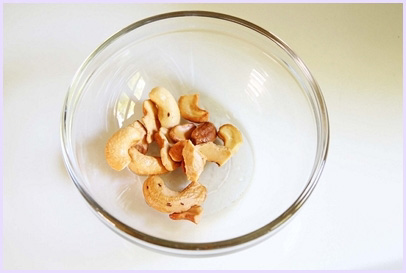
142, 175, 207, 213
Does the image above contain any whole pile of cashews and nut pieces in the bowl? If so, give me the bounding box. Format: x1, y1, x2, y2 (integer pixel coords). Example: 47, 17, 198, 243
105, 87, 243, 224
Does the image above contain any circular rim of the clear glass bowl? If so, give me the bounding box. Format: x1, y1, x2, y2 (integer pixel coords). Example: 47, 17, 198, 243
60, 10, 330, 255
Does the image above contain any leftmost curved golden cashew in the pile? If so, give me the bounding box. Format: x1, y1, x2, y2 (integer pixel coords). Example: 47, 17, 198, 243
104, 120, 146, 171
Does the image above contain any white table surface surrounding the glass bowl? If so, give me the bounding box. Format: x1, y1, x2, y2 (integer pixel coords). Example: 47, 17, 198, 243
2, 4, 403, 269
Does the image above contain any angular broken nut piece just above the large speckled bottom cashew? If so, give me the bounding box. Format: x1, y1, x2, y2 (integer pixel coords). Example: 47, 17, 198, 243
182, 140, 206, 181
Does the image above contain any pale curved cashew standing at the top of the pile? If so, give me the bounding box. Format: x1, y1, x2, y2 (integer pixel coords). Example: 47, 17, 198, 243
149, 87, 180, 128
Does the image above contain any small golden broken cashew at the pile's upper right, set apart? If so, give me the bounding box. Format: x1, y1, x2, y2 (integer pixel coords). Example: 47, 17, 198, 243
179, 94, 210, 122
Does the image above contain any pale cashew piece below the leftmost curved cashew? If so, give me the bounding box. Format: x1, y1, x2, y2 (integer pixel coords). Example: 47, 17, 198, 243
128, 147, 168, 175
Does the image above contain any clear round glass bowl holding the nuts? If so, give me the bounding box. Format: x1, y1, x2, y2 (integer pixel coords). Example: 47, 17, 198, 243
61, 11, 329, 255
